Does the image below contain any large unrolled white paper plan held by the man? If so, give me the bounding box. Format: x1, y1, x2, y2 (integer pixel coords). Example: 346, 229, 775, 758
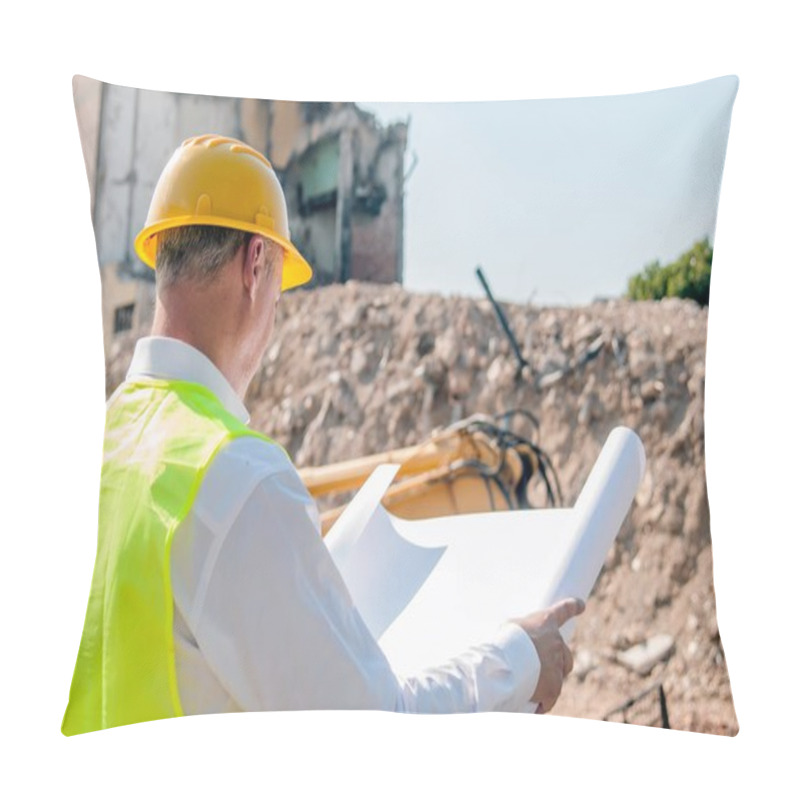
325, 428, 645, 673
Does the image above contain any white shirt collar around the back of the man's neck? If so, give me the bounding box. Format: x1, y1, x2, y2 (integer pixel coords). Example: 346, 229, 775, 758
126, 336, 250, 424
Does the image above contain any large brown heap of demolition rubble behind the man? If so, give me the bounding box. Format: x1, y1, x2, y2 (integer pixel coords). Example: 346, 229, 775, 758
107, 281, 738, 735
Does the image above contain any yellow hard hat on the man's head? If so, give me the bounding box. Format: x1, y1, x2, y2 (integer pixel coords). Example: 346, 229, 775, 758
134, 134, 312, 290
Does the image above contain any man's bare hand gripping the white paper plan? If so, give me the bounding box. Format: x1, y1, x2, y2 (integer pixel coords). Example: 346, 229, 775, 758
513, 597, 586, 714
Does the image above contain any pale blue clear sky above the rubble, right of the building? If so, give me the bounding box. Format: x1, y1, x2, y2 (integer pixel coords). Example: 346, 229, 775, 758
359, 77, 738, 305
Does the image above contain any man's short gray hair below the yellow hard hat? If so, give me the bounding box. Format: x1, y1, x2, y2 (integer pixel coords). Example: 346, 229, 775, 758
156, 225, 279, 287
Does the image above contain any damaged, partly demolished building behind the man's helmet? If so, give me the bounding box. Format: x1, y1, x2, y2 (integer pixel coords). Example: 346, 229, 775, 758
73, 76, 408, 351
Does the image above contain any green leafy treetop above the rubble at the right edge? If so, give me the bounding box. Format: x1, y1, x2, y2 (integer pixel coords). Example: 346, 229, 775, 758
627, 238, 714, 306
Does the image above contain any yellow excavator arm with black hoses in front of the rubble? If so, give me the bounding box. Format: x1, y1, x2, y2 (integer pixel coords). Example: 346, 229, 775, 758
300, 409, 562, 535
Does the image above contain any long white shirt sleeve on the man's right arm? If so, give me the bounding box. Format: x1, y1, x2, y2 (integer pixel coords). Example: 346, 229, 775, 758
192, 456, 540, 713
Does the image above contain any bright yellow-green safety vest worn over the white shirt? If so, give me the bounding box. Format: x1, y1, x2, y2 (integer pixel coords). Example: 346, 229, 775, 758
61, 380, 272, 736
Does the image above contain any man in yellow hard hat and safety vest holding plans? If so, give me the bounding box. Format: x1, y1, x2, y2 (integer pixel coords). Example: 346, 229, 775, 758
62, 135, 583, 735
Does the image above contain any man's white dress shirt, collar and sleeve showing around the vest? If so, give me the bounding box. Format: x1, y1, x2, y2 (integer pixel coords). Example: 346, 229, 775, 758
119, 337, 540, 714
